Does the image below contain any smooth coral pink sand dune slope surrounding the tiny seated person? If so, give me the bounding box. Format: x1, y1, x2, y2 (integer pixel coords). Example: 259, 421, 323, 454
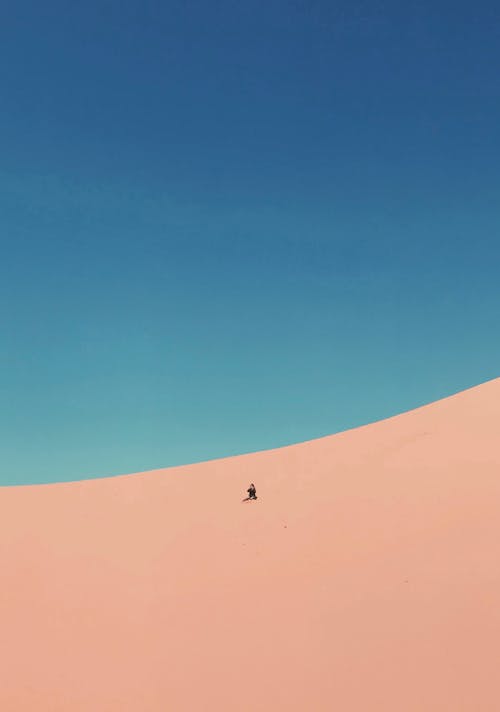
0, 380, 500, 712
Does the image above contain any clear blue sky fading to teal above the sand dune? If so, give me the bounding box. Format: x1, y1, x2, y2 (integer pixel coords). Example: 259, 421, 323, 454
0, 0, 500, 484
